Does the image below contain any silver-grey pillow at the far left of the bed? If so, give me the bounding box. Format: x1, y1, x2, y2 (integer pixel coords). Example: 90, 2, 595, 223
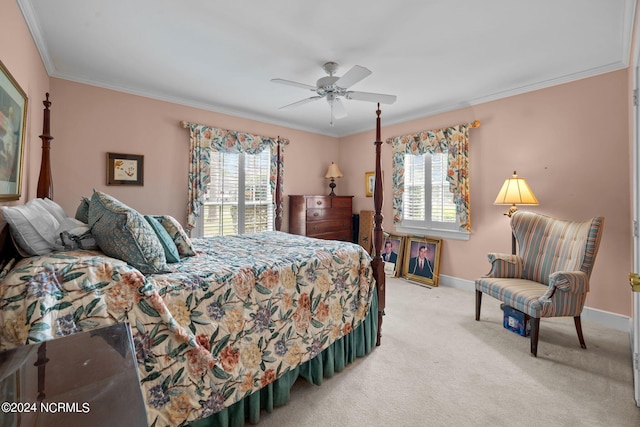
2, 199, 64, 255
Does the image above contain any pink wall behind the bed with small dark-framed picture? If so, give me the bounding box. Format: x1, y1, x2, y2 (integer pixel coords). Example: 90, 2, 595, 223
51, 78, 338, 225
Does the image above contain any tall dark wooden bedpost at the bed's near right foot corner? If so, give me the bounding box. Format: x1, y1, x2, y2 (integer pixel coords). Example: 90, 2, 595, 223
371, 104, 386, 345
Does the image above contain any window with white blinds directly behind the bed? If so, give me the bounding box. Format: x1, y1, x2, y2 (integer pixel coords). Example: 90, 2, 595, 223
198, 150, 274, 236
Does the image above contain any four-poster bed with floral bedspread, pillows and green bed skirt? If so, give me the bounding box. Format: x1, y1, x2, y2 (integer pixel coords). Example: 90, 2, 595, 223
0, 94, 385, 426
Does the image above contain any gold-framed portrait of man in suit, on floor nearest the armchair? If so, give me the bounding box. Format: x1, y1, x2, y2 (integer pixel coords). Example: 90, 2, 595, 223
402, 236, 442, 286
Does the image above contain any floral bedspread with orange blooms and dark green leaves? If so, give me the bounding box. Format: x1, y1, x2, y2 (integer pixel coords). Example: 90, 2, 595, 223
0, 232, 374, 426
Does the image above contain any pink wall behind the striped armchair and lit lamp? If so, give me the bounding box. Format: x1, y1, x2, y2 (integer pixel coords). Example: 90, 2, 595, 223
340, 70, 632, 316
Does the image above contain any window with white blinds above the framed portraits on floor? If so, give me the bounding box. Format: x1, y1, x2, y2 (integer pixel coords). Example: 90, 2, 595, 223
400, 151, 459, 236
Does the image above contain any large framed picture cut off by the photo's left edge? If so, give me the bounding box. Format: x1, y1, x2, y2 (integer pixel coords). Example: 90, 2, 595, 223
0, 61, 27, 202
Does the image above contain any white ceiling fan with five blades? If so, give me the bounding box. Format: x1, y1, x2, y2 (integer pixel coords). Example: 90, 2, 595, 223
271, 62, 396, 126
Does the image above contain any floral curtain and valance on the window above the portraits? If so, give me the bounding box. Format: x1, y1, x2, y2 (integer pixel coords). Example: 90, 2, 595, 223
387, 121, 480, 231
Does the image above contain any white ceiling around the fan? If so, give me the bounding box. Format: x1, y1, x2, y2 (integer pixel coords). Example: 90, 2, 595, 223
17, 0, 636, 137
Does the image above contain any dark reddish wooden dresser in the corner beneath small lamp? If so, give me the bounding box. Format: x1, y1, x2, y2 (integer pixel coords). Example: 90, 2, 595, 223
289, 196, 353, 242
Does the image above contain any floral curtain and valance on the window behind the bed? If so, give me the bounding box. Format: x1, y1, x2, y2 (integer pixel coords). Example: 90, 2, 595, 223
180, 121, 289, 232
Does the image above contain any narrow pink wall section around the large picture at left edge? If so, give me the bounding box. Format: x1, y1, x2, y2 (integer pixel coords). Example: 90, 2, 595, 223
0, 0, 49, 204
